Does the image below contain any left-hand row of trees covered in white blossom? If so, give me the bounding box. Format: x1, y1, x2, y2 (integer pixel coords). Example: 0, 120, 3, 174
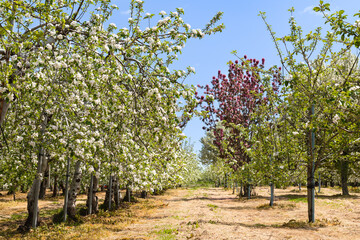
0, 0, 224, 228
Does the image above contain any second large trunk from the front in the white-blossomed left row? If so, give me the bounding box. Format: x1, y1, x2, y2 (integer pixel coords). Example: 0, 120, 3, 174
67, 161, 81, 219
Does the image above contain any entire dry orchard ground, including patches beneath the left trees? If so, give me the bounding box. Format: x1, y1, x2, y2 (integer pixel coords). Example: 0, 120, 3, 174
0, 187, 360, 240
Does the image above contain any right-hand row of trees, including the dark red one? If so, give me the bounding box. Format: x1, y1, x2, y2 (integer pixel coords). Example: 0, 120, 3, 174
198, 1, 360, 222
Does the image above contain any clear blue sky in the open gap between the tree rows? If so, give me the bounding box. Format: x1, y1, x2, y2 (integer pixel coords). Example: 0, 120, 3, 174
113, 0, 360, 152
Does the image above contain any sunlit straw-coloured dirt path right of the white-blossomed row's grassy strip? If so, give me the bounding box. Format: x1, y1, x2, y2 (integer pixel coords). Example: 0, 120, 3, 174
106, 188, 360, 240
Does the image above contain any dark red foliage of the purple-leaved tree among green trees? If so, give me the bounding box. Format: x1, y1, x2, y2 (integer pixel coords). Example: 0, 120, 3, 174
196, 55, 280, 168
